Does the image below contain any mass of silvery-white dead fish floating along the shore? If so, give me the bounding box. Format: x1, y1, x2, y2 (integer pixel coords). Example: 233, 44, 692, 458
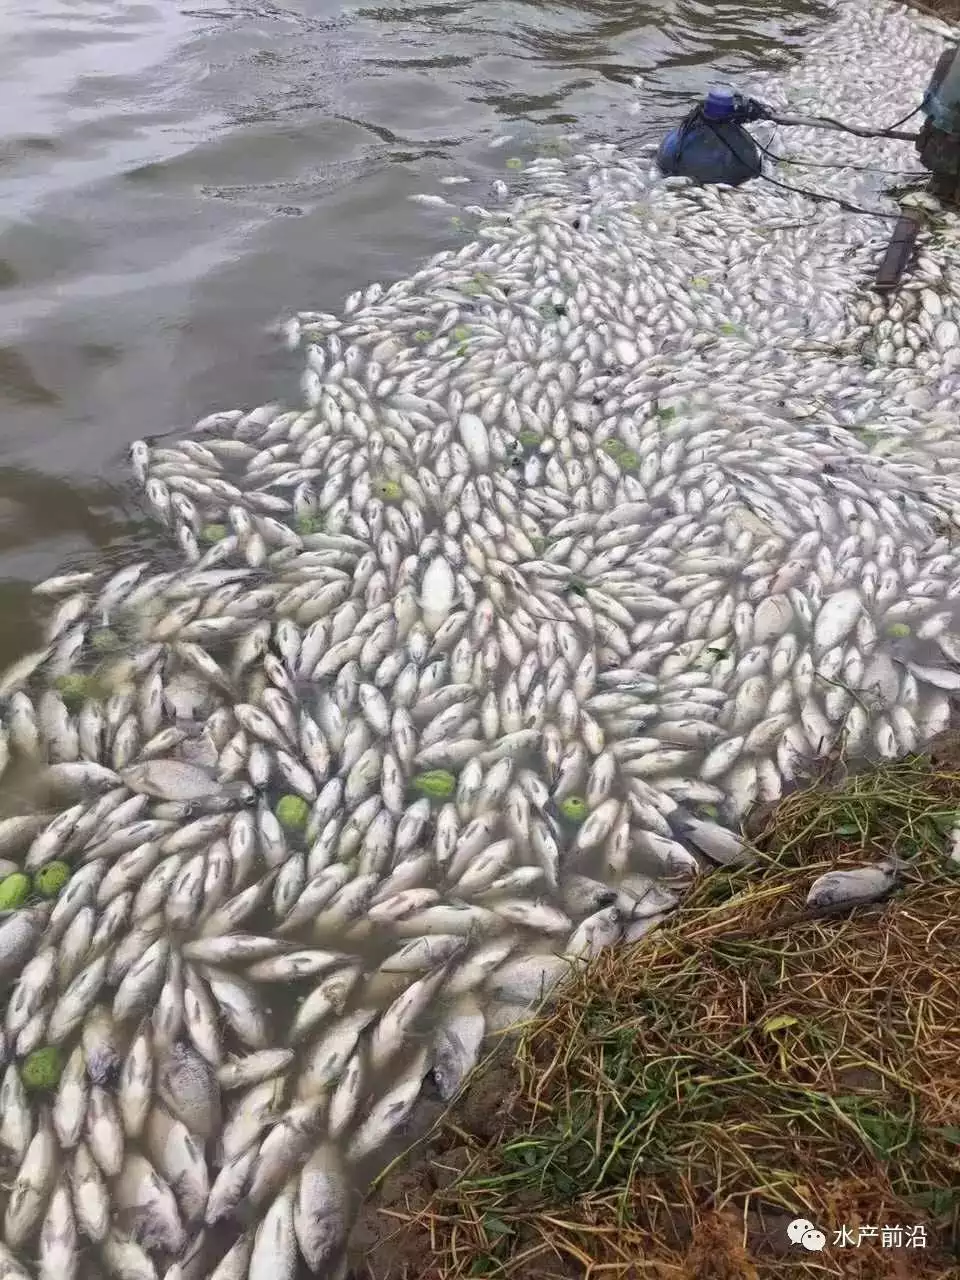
0, 4, 960, 1280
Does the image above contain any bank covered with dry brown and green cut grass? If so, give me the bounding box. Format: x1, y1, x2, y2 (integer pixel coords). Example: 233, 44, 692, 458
353, 740, 960, 1280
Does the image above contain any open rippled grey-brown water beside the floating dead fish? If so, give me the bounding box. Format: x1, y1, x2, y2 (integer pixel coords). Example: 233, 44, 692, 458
0, 0, 818, 659
